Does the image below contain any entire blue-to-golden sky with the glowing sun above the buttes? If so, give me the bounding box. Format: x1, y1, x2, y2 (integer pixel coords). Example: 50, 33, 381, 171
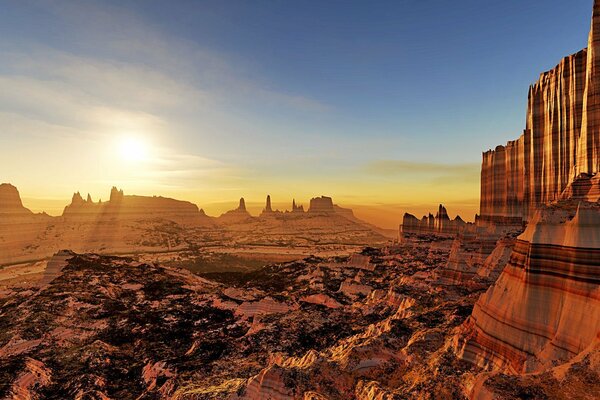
0, 0, 592, 228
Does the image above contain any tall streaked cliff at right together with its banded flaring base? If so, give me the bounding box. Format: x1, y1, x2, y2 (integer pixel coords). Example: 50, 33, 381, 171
455, 1, 600, 382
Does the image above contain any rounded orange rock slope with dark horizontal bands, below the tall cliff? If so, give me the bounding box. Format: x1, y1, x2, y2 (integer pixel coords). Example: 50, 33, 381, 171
457, 202, 600, 373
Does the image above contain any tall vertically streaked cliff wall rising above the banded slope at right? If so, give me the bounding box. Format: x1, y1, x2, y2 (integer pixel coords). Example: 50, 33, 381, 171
481, 3, 600, 224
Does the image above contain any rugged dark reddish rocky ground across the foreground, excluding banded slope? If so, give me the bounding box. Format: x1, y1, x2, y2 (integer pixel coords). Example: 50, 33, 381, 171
0, 238, 600, 399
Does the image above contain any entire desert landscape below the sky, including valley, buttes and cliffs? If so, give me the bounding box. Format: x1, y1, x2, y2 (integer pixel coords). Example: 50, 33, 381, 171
0, 1, 600, 400
